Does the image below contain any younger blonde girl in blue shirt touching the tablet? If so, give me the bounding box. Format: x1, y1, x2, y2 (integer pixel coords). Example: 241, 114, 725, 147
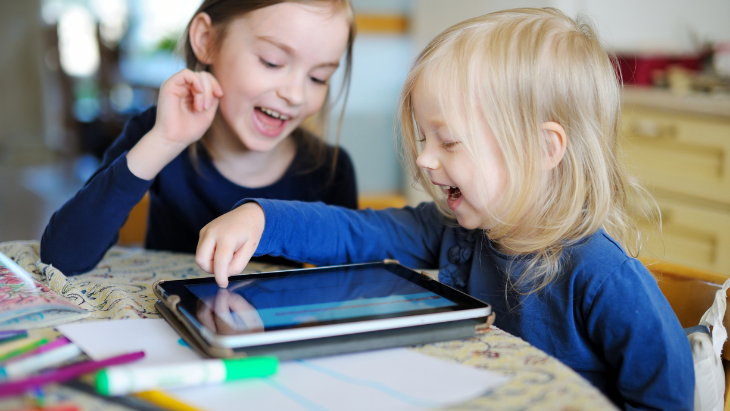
196, 9, 694, 410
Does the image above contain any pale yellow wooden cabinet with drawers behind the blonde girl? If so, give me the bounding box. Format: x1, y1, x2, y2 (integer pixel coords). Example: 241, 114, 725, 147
622, 88, 730, 275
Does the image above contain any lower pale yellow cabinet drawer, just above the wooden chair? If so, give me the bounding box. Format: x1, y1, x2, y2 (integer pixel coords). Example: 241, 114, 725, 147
638, 198, 730, 275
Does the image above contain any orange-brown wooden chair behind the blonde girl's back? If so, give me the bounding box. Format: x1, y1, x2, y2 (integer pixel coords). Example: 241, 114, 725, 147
642, 259, 730, 411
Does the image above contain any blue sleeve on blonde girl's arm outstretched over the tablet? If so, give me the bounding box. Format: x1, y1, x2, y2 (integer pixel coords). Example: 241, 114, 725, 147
242, 199, 445, 267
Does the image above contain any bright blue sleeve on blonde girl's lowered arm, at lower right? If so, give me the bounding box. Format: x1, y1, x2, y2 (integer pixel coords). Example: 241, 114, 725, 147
586, 259, 694, 410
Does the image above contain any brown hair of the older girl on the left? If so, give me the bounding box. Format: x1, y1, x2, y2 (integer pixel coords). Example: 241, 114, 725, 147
182, 0, 356, 175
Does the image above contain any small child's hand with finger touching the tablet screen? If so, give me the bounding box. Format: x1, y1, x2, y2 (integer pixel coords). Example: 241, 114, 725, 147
195, 203, 266, 288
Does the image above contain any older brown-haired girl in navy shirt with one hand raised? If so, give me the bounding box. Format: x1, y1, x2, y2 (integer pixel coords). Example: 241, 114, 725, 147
40, 0, 357, 275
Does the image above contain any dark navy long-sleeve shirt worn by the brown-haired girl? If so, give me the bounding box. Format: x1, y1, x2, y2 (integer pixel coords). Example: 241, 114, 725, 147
40, 107, 357, 275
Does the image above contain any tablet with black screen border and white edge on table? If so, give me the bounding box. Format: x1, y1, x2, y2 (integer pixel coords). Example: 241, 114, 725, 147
155, 260, 491, 348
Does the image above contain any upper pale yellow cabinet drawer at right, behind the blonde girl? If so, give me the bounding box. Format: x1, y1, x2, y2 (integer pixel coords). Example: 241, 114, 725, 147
623, 108, 730, 204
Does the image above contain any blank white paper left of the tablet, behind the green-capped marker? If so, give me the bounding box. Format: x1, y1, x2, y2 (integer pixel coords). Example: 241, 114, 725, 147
56, 320, 201, 364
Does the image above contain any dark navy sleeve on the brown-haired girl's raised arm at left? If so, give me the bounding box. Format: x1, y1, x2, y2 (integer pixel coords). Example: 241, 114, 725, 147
40, 108, 156, 275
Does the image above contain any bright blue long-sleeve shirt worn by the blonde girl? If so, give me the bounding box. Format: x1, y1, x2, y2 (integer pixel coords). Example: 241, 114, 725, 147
242, 199, 694, 410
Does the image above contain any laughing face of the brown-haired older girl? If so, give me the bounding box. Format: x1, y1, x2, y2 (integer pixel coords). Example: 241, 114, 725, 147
200, 2, 349, 152
